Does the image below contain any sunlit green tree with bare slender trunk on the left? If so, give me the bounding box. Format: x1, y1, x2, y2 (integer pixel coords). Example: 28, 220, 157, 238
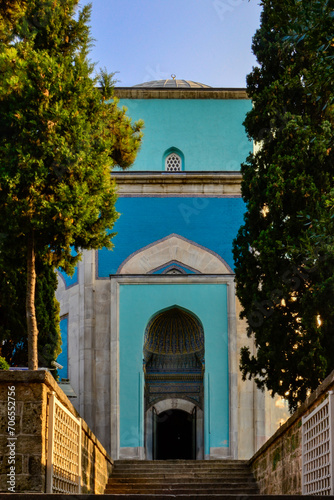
0, 0, 142, 369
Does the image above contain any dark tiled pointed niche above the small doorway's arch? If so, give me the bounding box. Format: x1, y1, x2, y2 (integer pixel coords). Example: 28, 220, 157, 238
143, 304, 205, 411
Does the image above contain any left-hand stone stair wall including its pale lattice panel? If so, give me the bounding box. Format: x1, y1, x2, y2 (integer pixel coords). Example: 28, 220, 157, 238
0, 371, 113, 494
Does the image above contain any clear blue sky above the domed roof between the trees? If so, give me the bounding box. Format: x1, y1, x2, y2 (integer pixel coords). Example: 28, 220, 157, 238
80, 0, 261, 87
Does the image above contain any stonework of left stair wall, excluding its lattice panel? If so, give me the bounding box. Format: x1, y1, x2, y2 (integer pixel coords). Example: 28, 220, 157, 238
0, 370, 112, 493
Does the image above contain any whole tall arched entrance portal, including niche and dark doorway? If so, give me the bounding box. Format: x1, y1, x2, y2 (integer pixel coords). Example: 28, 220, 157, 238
144, 306, 204, 460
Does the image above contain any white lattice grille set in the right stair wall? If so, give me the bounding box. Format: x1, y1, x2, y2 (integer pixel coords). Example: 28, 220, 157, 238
302, 391, 334, 495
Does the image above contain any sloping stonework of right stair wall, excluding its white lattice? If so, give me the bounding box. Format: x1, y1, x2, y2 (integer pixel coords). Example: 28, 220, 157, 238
249, 371, 334, 495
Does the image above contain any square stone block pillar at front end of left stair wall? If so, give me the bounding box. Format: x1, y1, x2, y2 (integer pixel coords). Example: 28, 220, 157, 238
0, 371, 47, 493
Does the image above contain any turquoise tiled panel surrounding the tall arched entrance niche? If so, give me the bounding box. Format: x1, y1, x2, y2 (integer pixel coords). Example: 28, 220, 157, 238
119, 284, 229, 454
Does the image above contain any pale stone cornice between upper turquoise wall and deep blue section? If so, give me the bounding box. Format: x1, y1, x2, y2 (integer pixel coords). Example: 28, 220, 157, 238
112, 172, 242, 197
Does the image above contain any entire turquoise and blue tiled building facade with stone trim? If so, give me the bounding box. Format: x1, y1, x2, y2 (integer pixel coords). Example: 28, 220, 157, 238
55, 82, 280, 459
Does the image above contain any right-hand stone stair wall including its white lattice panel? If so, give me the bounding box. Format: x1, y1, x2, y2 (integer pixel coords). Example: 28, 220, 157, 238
249, 371, 334, 495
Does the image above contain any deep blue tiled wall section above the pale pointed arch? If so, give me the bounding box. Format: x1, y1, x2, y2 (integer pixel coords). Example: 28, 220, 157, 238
98, 198, 245, 278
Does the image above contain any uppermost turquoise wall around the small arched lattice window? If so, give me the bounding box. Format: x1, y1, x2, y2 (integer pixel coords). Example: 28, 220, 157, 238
120, 99, 252, 171
